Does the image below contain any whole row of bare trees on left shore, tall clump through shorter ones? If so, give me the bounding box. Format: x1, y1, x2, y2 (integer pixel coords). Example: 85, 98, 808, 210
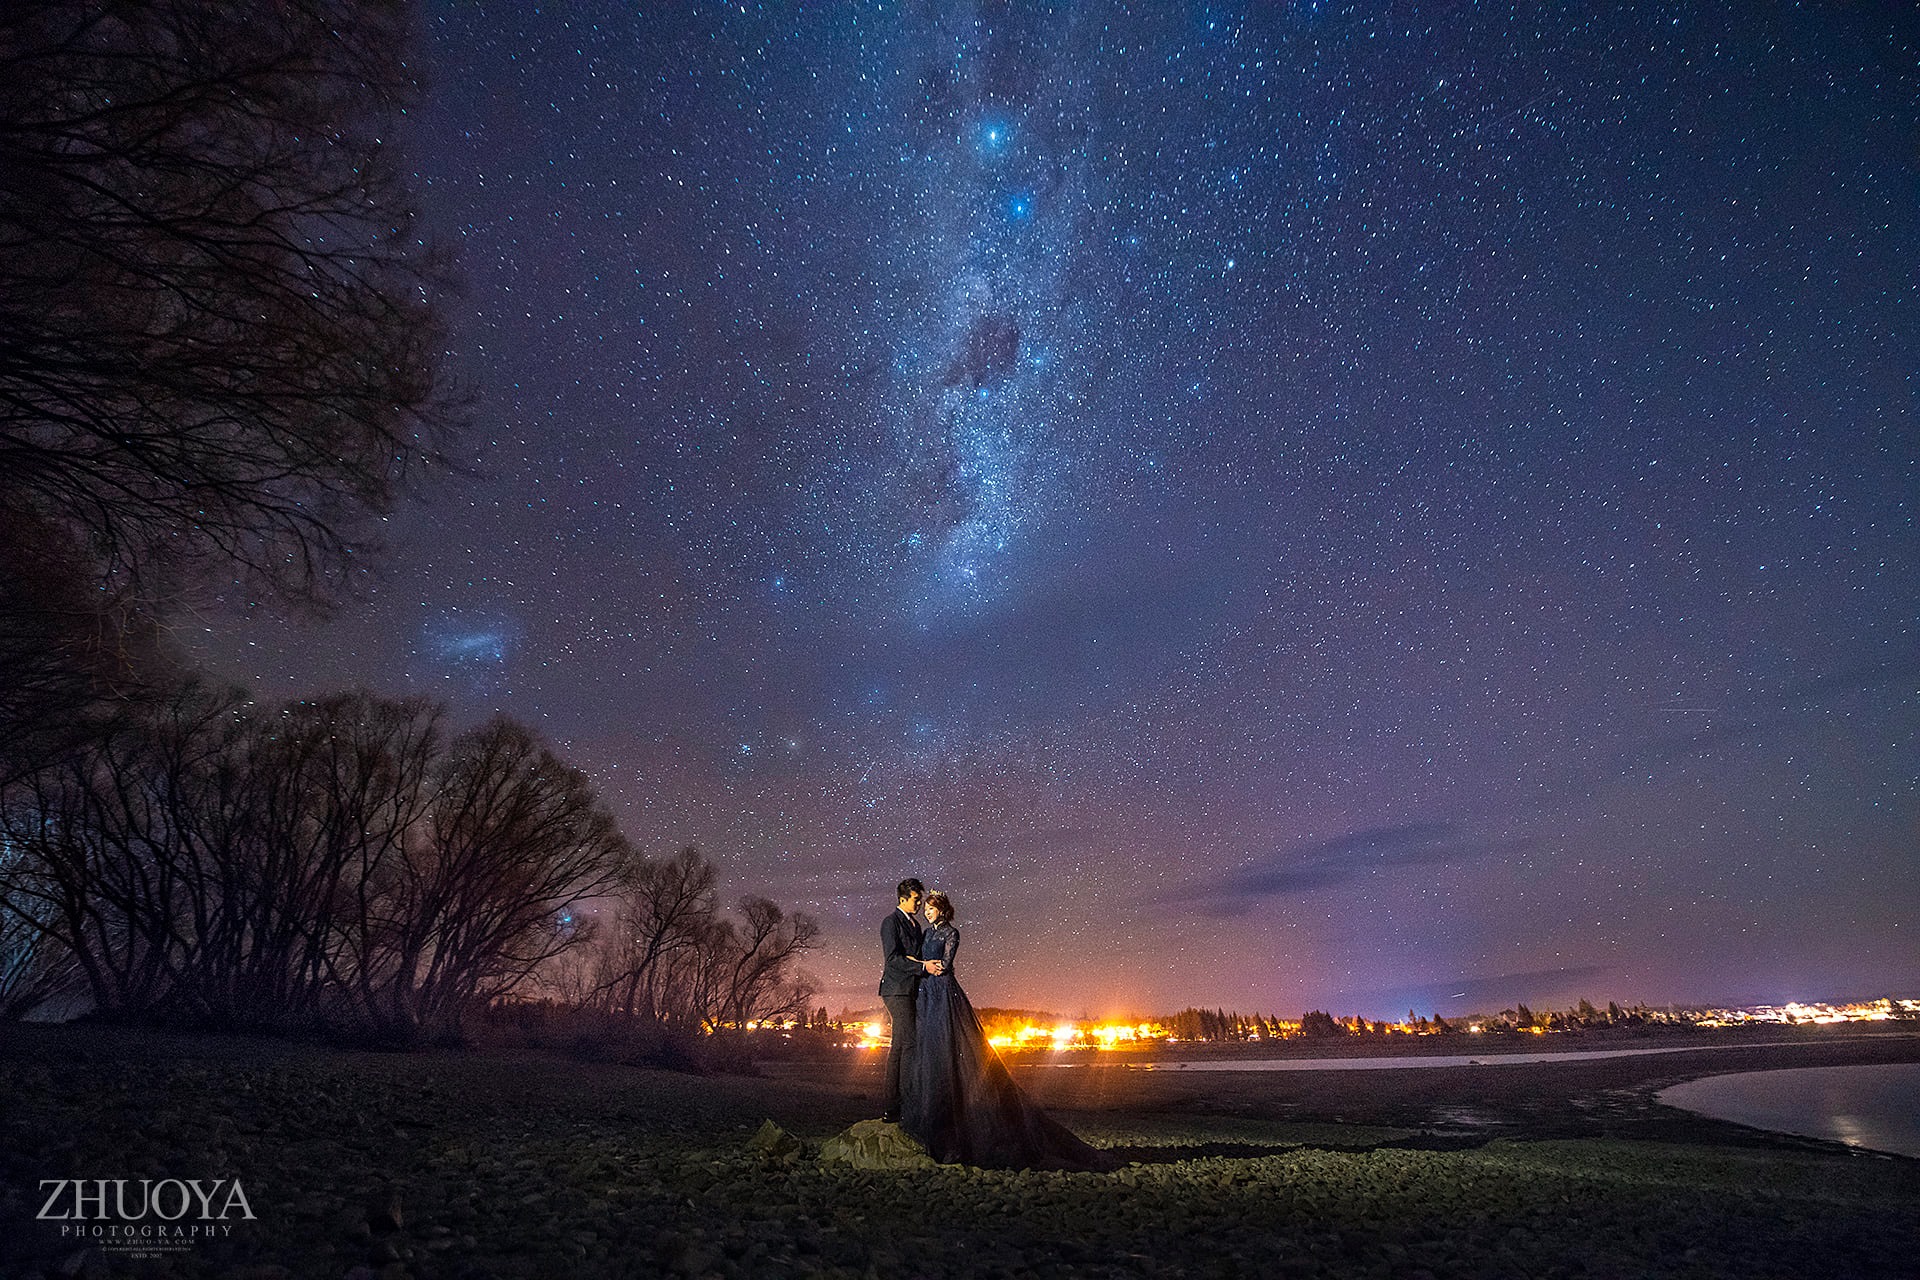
0, 685, 818, 1040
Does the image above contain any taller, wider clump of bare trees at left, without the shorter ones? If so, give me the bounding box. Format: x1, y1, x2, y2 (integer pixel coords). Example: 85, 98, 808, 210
0, 689, 622, 1038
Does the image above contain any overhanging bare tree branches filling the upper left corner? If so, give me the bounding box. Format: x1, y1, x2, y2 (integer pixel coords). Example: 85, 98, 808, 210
0, 0, 453, 771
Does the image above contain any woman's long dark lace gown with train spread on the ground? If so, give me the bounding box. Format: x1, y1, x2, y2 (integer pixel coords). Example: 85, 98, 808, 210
900, 925, 1117, 1169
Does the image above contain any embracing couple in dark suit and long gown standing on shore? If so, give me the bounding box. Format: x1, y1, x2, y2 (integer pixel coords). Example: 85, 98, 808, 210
879, 879, 1116, 1169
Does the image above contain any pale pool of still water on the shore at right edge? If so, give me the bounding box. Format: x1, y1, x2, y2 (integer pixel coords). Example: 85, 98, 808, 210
1659, 1063, 1920, 1157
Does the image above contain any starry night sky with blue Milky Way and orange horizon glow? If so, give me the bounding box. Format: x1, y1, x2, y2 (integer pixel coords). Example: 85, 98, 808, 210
190, 0, 1920, 1017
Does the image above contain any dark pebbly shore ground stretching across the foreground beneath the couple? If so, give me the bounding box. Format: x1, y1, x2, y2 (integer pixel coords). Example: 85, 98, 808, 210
0, 1027, 1920, 1280
